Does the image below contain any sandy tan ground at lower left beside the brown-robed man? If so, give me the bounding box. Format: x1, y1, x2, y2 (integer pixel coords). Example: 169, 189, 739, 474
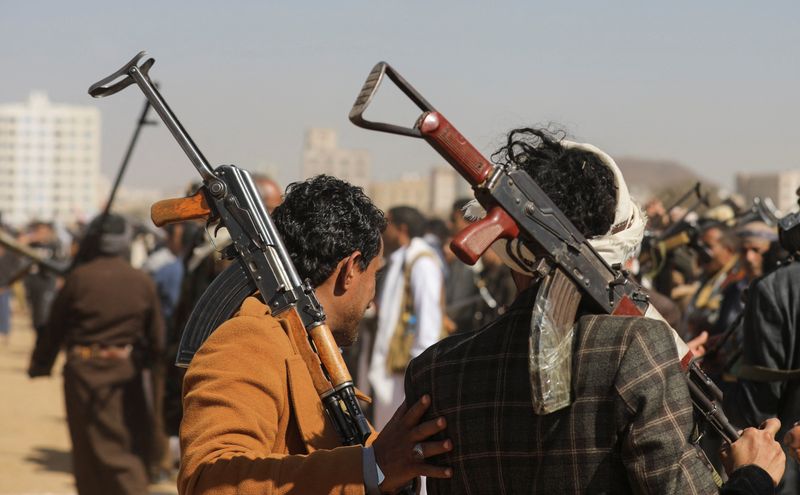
0, 304, 177, 495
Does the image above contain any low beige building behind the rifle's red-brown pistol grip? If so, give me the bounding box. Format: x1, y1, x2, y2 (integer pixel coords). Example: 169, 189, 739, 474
370, 165, 466, 218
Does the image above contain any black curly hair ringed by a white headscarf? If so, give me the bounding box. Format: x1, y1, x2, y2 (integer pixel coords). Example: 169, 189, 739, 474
492, 127, 617, 237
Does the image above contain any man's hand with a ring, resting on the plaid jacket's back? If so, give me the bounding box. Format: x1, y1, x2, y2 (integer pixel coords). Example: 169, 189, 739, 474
372, 395, 453, 493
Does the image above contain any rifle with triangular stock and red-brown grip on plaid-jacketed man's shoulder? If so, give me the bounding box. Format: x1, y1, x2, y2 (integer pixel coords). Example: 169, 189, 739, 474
350, 62, 739, 443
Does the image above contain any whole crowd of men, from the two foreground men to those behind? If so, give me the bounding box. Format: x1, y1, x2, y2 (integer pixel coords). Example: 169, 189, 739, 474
0, 129, 800, 495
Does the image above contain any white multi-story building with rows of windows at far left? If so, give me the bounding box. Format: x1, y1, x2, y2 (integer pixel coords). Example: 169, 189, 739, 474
0, 92, 100, 225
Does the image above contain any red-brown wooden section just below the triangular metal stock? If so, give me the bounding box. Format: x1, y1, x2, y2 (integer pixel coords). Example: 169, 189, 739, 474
417, 112, 494, 186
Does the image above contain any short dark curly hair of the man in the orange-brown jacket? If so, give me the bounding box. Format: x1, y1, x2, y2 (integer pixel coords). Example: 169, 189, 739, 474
272, 175, 386, 287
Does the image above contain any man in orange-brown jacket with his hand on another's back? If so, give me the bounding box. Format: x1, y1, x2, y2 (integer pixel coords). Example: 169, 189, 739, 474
183, 176, 452, 495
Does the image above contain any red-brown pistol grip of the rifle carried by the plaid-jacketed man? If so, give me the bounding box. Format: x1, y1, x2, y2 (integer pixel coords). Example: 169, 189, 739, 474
450, 206, 519, 265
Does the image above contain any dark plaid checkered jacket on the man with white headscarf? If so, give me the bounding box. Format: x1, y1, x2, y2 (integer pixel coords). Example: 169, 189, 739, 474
406, 290, 717, 495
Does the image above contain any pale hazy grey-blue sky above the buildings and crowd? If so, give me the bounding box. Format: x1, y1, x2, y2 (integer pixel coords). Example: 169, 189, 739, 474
0, 0, 800, 192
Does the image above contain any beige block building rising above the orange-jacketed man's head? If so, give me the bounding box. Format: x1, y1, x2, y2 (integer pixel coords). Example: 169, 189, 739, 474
303, 129, 372, 190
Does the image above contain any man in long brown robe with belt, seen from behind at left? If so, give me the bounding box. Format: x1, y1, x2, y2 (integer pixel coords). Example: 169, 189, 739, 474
28, 215, 164, 495
